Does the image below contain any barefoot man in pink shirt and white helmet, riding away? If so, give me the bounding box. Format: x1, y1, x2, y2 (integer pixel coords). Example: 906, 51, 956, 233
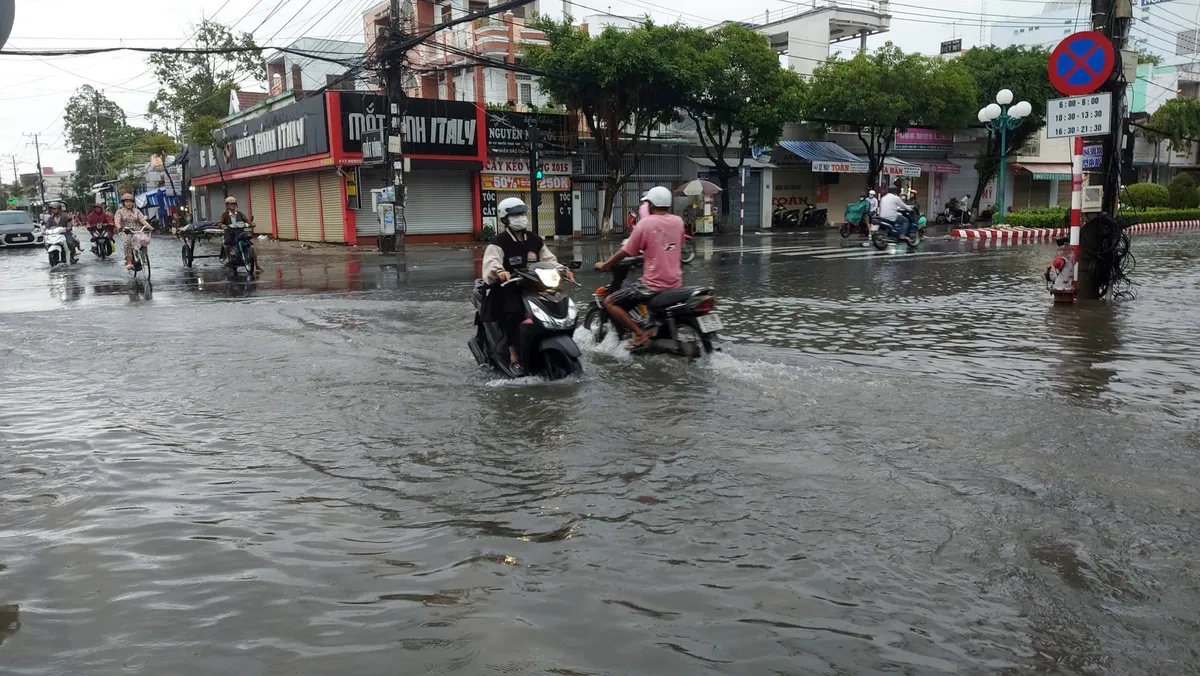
595, 186, 684, 349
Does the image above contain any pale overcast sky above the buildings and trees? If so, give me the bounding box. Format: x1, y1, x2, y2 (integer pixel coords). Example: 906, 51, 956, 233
0, 0, 1042, 174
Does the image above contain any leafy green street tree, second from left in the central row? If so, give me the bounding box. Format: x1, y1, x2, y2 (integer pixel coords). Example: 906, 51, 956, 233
683, 24, 804, 223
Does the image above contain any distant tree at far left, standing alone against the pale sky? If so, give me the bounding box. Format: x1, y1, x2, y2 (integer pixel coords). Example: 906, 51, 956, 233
62, 84, 130, 195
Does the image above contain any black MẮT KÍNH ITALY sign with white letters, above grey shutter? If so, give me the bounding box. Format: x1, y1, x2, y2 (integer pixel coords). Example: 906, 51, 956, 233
340, 91, 482, 160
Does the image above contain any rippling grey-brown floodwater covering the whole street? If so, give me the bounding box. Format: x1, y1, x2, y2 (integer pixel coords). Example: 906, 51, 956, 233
0, 234, 1200, 676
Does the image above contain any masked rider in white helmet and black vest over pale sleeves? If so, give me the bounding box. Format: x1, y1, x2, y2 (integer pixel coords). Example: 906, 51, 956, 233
484, 197, 575, 375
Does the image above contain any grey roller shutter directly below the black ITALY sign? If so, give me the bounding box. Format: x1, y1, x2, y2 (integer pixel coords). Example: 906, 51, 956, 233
404, 172, 475, 234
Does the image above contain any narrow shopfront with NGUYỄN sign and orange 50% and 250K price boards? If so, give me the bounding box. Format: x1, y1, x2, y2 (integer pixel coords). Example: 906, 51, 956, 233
480, 110, 575, 243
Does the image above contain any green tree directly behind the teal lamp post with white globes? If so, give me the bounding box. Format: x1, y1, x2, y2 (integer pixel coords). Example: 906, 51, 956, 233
956, 46, 1060, 213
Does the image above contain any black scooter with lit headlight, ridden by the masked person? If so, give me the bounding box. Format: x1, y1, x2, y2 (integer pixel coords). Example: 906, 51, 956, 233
467, 261, 583, 381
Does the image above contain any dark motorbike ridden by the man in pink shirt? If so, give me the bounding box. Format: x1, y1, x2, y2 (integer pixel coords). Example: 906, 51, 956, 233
583, 256, 725, 359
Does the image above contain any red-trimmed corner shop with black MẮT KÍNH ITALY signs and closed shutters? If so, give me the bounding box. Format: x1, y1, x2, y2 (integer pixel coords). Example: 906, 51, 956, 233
191, 91, 486, 244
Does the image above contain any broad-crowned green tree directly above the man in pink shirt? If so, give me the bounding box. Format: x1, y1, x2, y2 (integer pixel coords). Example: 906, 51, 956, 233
523, 18, 698, 234
